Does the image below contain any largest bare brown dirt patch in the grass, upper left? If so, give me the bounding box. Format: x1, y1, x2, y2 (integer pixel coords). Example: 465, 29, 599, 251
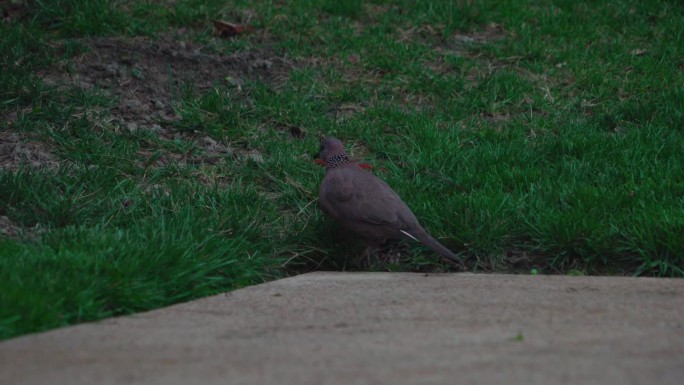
44, 33, 290, 135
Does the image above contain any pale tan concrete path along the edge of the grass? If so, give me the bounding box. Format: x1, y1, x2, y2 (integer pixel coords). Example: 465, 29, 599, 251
0, 273, 684, 385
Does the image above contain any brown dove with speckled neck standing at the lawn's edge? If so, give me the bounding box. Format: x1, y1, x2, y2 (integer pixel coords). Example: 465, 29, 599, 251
317, 137, 462, 266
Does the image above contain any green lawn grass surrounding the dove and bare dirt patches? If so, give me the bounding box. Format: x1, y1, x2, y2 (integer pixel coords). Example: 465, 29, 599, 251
0, 0, 684, 338
